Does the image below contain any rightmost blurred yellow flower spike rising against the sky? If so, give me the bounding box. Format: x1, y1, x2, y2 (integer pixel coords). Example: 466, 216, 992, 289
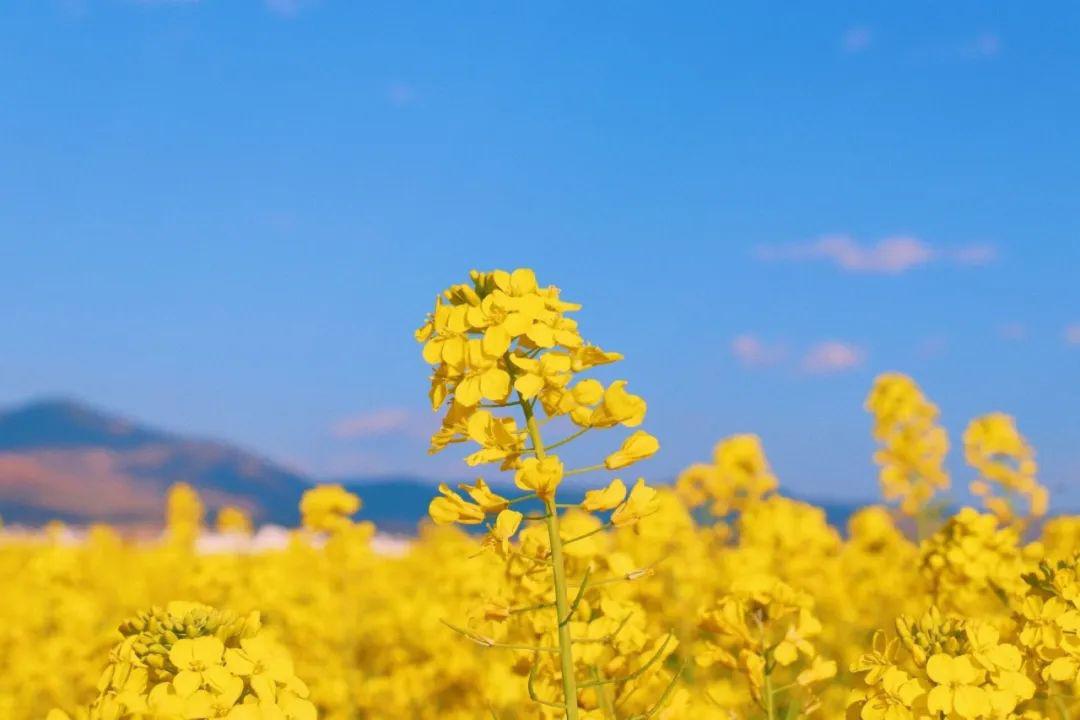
963, 412, 1050, 522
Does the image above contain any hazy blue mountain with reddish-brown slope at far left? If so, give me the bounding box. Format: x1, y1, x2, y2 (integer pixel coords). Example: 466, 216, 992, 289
0, 399, 313, 525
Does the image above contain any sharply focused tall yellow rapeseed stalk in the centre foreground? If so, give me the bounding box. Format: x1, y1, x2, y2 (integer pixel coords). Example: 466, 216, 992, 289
416, 269, 677, 720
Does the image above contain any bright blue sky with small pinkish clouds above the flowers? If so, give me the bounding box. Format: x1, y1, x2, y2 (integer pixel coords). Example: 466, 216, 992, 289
0, 0, 1080, 506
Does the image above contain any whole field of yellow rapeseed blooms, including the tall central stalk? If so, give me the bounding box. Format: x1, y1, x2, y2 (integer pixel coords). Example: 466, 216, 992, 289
0, 270, 1080, 720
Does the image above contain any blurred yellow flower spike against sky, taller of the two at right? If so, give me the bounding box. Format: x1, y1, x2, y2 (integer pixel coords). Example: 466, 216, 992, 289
866, 372, 949, 515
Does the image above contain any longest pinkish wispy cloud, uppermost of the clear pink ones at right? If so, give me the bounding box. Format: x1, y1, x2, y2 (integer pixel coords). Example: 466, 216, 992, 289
755, 235, 997, 275
